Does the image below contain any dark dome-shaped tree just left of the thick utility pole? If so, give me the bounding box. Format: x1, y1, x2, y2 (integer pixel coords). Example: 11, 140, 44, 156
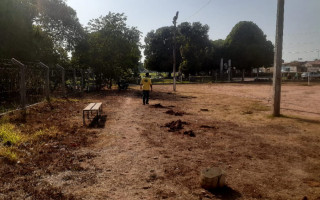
225, 21, 274, 79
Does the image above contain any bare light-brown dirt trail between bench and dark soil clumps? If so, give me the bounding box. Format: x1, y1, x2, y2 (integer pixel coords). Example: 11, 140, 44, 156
56, 93, 181, 199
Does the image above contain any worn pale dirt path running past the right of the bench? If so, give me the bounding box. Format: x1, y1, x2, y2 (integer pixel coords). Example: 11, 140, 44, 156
78, 97, 159, 199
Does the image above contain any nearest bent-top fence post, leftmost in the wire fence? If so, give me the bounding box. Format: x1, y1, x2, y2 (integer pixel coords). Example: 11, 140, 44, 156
11, 58, 27, 117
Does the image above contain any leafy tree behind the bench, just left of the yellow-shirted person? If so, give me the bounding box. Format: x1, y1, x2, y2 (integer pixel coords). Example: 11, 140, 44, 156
73, 12, 141, 87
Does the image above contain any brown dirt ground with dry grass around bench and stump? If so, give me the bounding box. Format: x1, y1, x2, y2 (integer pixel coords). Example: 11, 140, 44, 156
0, 84, 320, 200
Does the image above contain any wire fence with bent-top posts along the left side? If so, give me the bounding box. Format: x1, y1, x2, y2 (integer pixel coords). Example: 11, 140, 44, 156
0, 59, 96, 114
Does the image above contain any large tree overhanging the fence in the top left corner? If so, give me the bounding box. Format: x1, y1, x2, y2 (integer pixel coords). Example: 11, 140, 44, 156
0, 0, 83, 60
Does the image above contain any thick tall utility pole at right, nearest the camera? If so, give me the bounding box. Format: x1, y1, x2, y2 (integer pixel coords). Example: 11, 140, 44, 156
272, 0, 284, 117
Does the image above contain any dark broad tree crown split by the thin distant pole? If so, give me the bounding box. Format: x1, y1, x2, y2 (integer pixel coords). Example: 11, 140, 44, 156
144, 22, 212, 74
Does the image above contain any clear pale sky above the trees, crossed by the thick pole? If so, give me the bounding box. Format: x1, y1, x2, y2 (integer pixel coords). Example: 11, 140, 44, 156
67, 0, 320, 62
